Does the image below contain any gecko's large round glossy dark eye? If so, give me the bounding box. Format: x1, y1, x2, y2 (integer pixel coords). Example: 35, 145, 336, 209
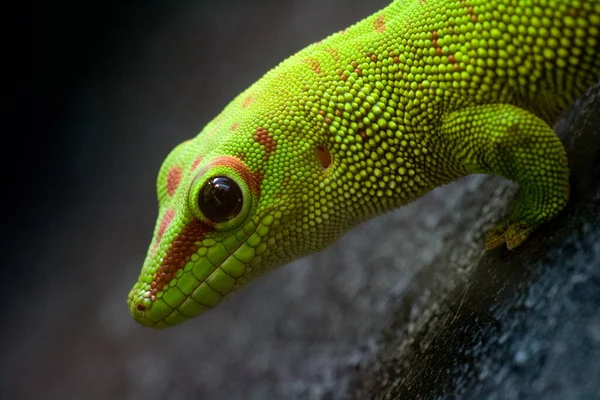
198, 176, 243, 222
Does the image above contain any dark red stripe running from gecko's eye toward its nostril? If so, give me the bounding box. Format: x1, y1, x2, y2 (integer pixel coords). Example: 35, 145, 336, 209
150, 220, 214, 296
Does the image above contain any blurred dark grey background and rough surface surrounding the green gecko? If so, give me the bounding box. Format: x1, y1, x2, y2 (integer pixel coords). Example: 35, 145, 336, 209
8, 0, 600, 400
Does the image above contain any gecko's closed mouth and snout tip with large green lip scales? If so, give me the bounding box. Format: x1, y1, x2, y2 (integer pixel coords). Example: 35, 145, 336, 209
129, 212, 274, 328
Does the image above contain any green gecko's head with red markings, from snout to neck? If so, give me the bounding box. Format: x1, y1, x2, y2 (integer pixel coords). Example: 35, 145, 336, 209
128, 114, 337, 328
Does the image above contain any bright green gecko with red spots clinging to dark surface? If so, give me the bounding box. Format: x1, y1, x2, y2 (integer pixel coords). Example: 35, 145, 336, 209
128, 0, 600, 328
